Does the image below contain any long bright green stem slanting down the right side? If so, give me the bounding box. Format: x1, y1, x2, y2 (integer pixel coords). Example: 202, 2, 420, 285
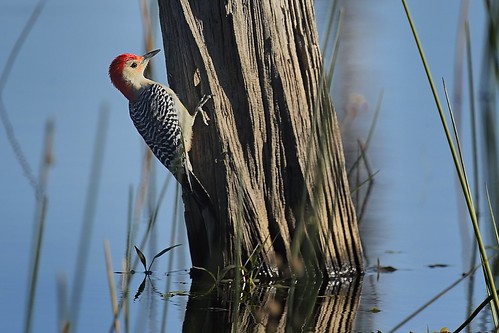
402, 0, 499, 327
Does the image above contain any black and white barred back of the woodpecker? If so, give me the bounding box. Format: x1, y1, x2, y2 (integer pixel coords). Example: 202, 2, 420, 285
129, 84, 185, 178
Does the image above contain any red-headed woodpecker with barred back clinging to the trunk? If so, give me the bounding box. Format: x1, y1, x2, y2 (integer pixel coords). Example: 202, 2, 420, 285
109, 50, 211, 204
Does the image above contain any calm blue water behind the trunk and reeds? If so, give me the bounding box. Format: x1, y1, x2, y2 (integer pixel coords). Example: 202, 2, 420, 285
0, 0, 490, 332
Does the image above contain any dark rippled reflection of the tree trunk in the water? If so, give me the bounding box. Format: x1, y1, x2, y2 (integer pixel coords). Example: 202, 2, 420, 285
182, 280, 361, 333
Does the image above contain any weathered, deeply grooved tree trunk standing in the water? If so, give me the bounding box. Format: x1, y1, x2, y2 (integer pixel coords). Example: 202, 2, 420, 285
159, 0, 362, 278
